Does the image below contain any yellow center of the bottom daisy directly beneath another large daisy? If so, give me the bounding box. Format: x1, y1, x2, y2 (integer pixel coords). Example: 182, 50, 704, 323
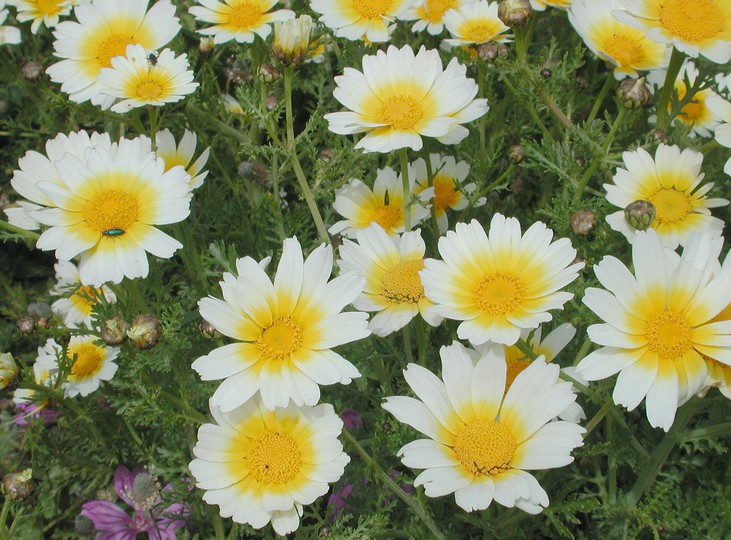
246, 431, 302, 485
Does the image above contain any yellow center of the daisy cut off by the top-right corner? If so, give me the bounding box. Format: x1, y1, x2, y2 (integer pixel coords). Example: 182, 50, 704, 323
659, 0, 725, 43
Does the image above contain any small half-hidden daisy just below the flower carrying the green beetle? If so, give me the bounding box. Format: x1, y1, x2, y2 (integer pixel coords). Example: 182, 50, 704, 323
51, 261, 117, 328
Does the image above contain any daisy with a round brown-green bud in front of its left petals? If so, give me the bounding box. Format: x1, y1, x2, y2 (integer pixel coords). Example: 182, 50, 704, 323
604, 144, 728, 249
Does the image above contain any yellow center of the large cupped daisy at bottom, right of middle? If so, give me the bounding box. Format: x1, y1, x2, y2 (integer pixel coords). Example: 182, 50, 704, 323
452, 420, 518, 476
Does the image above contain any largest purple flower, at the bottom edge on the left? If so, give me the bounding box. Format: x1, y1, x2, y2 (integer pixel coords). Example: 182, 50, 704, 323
81, 466, 188, 540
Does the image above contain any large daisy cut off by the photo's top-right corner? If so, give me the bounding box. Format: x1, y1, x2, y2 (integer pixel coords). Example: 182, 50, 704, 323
615, 0, 731, 64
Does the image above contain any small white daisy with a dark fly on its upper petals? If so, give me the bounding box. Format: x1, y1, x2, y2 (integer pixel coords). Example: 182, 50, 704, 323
97, 44, 198, 113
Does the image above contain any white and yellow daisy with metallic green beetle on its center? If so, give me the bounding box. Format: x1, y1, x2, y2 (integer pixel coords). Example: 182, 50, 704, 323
28, 139, 190, 287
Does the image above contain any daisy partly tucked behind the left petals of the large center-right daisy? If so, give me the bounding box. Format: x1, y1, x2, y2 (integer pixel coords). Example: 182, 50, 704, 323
338, 223, 442, 337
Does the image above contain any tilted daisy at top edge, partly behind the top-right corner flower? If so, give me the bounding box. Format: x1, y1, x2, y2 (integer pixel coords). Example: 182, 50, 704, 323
569, 0, 670, 79
